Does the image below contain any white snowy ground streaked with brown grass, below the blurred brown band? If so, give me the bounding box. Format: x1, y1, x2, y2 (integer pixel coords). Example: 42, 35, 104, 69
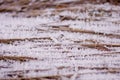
0, 0, 120, 80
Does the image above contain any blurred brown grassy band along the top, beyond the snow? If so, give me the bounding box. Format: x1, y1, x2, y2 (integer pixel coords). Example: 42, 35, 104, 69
0, 0, 120, 17
